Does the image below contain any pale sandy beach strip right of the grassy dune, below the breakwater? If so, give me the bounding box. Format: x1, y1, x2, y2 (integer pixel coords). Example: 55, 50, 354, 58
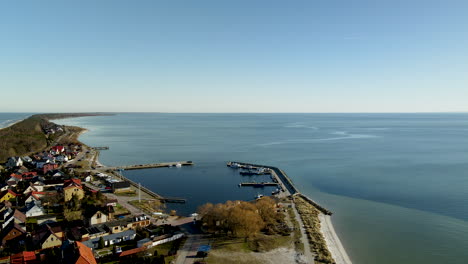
319, 214, 352, 264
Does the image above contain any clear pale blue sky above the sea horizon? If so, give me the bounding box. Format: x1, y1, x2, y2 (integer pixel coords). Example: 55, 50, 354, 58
0, 0, 468, 112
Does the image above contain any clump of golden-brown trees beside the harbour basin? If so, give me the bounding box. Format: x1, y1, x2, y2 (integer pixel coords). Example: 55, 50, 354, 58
198, 197, 284, 237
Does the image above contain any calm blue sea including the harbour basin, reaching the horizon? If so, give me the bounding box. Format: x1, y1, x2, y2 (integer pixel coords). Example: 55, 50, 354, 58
0, 113, 468, 264
